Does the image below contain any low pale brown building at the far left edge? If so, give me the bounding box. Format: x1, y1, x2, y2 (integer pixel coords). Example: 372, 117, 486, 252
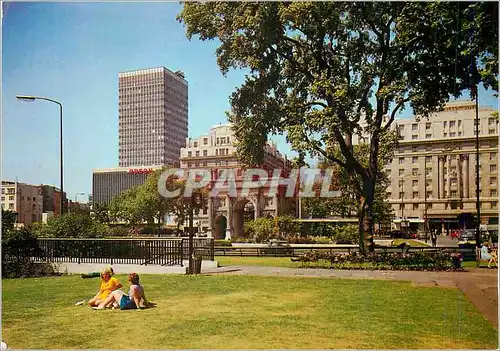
2, 181, 43, 226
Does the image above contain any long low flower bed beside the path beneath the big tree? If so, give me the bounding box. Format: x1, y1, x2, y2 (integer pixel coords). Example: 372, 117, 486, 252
295, 251, 463, 271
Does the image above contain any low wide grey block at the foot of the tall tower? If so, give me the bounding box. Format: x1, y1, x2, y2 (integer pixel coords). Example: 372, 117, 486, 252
92, 166, 162, 205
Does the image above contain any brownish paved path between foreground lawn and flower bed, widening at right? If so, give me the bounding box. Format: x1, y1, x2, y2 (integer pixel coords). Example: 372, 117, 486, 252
203, 266, 498, 329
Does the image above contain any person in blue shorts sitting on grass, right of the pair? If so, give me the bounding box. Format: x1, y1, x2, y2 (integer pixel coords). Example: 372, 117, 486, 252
97, 273, 154, 310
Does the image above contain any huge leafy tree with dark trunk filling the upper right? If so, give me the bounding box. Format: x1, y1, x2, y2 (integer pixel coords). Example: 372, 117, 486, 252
178, 2, 498, 252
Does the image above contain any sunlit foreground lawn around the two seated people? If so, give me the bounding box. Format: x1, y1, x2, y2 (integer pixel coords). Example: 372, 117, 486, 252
2, 275, 497, 349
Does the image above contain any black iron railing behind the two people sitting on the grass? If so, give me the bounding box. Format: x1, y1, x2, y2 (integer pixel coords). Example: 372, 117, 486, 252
33, 238, 184, 266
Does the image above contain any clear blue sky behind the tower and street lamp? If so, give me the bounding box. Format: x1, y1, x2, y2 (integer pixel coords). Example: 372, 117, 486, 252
1, 2, 497, 201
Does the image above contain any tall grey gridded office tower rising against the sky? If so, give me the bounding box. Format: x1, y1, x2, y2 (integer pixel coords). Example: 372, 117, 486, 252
118, 67, 188, 167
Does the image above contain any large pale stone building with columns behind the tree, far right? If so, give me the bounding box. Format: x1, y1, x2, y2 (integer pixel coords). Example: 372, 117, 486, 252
386, 101, 498, 231
